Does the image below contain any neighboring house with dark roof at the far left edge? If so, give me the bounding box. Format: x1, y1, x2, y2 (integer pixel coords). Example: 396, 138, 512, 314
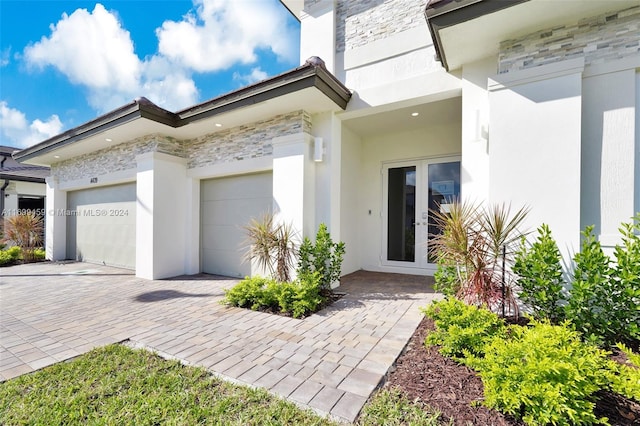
0, 145, 49, 234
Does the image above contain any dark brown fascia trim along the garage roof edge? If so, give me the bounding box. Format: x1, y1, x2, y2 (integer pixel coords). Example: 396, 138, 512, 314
13, 56, 351, 166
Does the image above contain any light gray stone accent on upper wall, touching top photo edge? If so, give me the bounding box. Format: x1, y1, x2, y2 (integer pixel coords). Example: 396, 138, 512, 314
336, 0, 427, 52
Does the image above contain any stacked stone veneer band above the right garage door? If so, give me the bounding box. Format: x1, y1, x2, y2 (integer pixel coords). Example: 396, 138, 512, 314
187, 111, 311, 168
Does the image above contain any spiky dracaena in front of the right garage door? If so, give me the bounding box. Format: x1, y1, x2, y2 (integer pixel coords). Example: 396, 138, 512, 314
244, 213, 297, 282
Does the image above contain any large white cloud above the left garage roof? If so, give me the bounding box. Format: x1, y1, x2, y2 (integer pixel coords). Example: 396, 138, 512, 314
24, 3, 198, 113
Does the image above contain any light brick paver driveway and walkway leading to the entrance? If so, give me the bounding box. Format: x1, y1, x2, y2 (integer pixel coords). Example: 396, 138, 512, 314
0, 263, 437, 421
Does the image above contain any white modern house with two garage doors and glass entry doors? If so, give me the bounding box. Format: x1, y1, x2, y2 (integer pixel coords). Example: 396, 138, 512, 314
15, 0, 640, 278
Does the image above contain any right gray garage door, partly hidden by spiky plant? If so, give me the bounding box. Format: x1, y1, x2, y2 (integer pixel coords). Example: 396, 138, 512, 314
201, 172, 273, 277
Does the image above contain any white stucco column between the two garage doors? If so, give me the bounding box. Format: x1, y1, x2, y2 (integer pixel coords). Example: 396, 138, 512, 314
136, 152, 189, 279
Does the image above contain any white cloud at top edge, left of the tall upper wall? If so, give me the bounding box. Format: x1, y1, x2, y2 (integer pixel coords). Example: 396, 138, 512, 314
156, 0, 297, 72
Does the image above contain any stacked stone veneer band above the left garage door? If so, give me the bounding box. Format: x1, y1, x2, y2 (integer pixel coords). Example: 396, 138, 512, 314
51, 134, 186, 181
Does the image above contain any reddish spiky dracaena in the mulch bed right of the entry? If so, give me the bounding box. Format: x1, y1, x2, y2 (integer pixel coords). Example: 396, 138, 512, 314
432, 201, 528, 313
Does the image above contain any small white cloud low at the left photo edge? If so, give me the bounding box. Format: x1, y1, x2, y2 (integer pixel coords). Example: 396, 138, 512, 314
0, 101, 62, 148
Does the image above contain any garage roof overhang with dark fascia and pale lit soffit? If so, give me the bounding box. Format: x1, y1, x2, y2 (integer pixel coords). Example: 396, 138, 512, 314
13, 57, 351, 166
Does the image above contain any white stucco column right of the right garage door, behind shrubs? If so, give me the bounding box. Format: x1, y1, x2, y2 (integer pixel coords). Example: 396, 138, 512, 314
272, 133, 315, 251
